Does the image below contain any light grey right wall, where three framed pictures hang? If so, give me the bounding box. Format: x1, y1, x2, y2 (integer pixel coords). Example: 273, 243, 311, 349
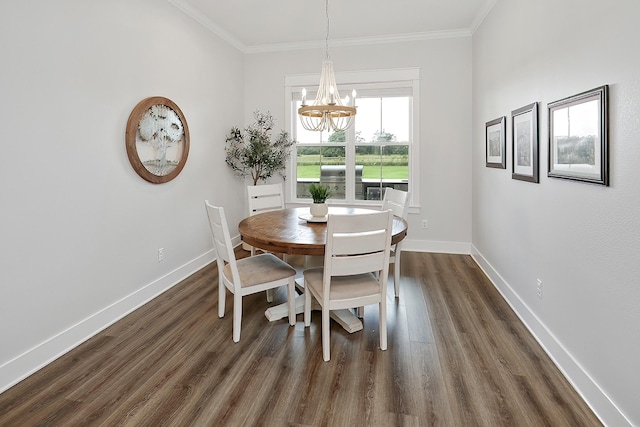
472, 0, 640, 426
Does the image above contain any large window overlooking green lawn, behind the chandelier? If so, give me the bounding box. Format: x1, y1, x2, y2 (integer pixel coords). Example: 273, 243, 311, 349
287, 69, 419, 205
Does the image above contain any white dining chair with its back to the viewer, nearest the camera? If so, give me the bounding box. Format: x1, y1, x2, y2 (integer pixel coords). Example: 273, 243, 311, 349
303, 211, 393, 361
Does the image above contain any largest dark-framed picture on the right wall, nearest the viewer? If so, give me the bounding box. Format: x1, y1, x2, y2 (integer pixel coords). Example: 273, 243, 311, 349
547, 85, 609, 185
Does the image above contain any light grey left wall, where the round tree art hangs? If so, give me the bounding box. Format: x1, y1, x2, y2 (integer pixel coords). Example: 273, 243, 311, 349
0, 0, 243, 391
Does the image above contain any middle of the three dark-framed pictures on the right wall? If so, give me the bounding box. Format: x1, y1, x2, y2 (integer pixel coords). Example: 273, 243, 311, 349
511, 102, 539, 182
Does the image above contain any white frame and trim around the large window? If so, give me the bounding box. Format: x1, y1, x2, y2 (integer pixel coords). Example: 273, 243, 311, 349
284, 68, 421, 210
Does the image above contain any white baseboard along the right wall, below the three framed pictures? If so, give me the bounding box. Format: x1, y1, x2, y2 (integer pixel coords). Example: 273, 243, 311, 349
471, 245, 632, 427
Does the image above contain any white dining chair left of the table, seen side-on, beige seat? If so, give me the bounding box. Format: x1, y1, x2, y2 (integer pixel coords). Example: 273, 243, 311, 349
205, 200, 296, 342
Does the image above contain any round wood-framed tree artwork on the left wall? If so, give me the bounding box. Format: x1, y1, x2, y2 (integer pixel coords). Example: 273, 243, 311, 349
125, 96, 189, 184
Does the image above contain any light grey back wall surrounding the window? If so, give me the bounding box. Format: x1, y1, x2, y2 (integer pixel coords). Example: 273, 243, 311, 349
244, 37, 471, 253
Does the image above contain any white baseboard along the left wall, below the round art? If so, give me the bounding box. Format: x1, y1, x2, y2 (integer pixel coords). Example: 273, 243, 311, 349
0, 251, 218, 393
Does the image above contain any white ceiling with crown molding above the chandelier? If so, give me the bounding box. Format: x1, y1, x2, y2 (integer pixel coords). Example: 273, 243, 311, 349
169, 0, 496, 52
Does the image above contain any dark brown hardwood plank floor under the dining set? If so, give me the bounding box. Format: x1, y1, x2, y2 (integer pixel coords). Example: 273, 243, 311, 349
0, 251, 601, 427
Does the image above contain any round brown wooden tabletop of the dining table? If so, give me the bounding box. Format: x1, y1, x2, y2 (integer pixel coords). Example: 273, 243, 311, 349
238, 206, 407, 255
